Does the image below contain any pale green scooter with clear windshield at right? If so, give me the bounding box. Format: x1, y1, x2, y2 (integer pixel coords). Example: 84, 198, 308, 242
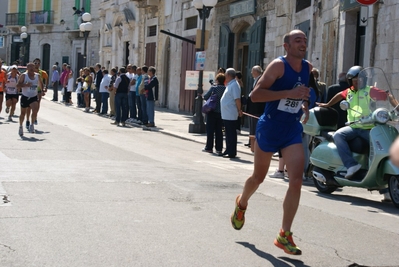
303, 67, 399, 208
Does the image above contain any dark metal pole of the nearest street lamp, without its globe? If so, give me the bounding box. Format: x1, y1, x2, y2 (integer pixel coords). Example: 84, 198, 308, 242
188, 6, 208, 133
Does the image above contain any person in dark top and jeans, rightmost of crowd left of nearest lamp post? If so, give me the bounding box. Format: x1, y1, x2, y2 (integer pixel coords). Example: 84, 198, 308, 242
144, 67, 159, 127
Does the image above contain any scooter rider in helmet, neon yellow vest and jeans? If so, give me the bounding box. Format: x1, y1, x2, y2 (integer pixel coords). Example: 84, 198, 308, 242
317, 66, 382, 179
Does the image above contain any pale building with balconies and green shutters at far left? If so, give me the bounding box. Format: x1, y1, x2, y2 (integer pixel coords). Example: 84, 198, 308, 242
5, 0, 100, 75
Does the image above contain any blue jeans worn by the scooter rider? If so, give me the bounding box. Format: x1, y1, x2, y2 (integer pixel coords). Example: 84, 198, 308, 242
333, 126, 370, 169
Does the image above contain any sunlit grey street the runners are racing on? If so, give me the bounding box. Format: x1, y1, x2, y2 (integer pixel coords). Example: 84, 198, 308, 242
0, 99, 399, 267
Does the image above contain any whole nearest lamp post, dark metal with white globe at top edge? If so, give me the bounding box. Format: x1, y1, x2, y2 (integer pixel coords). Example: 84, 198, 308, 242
188, 0, 218, 133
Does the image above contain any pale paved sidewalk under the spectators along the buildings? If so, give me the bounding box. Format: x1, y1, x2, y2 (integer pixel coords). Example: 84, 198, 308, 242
43, 93, 253, 156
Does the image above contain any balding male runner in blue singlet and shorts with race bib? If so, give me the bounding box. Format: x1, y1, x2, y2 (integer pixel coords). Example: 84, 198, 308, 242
231, 30, 312, 255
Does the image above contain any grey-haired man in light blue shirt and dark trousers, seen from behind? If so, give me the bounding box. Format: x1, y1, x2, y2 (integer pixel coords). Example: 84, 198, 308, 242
220, 68, 242, 158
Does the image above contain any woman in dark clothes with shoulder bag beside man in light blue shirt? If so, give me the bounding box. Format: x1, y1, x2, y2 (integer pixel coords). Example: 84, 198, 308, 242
202, 73, 226, 155
